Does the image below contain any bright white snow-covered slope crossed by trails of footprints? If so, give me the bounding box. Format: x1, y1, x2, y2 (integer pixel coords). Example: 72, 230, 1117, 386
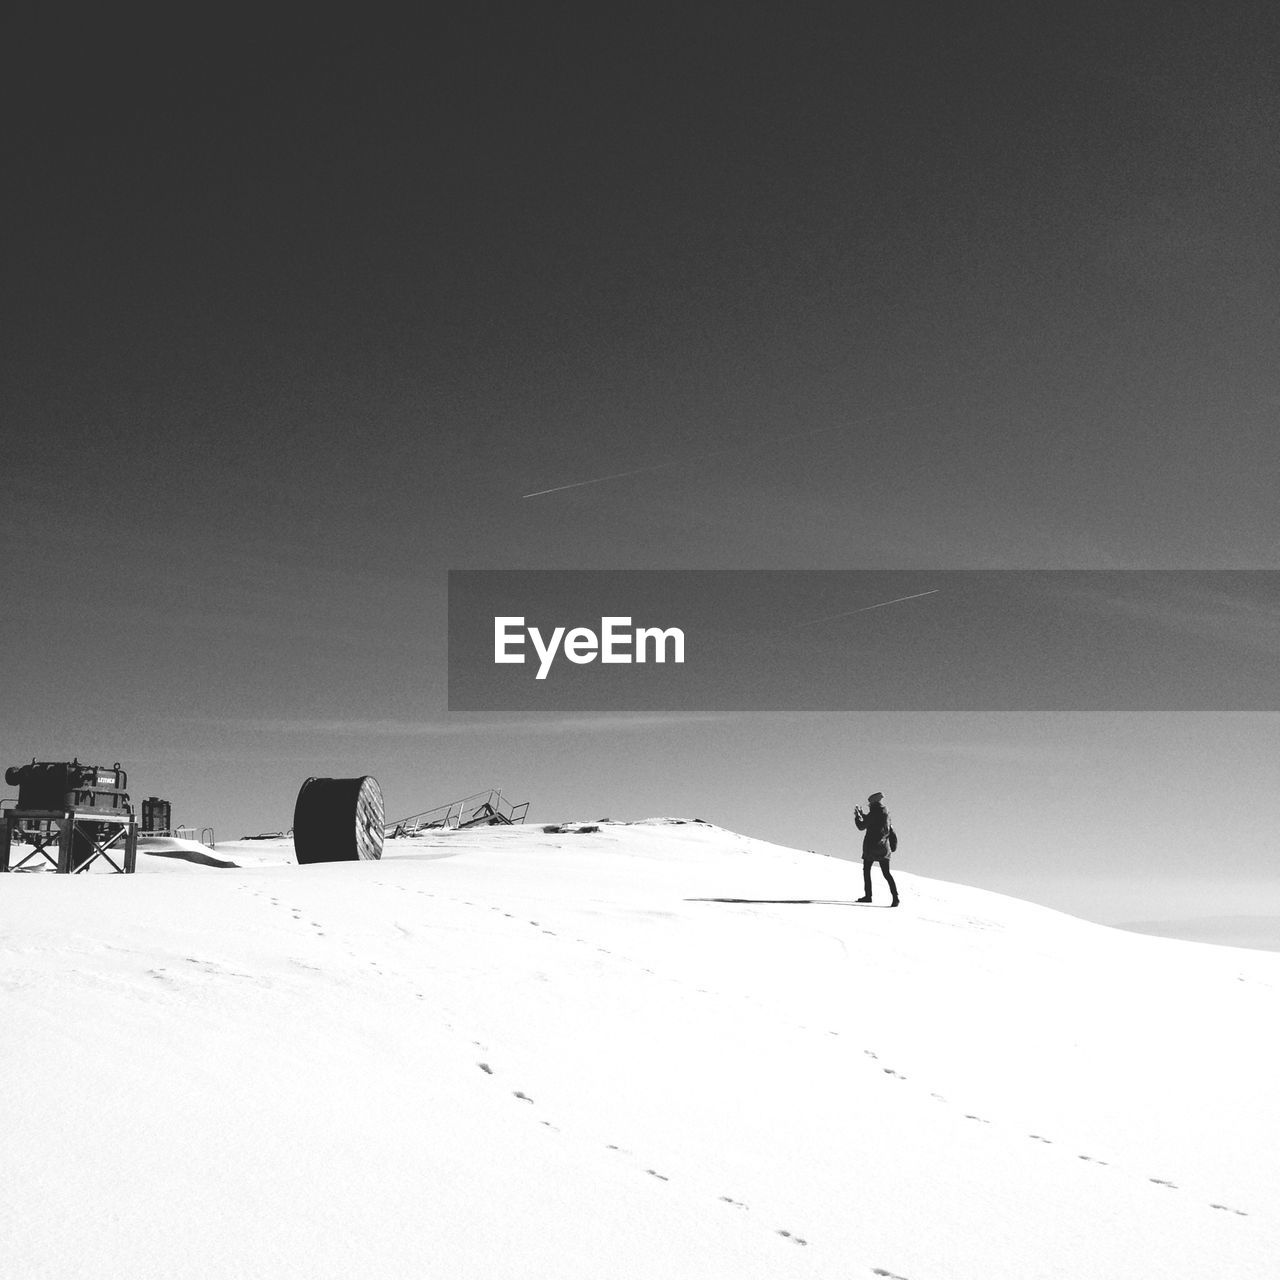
0, 820, 1280, 1280
